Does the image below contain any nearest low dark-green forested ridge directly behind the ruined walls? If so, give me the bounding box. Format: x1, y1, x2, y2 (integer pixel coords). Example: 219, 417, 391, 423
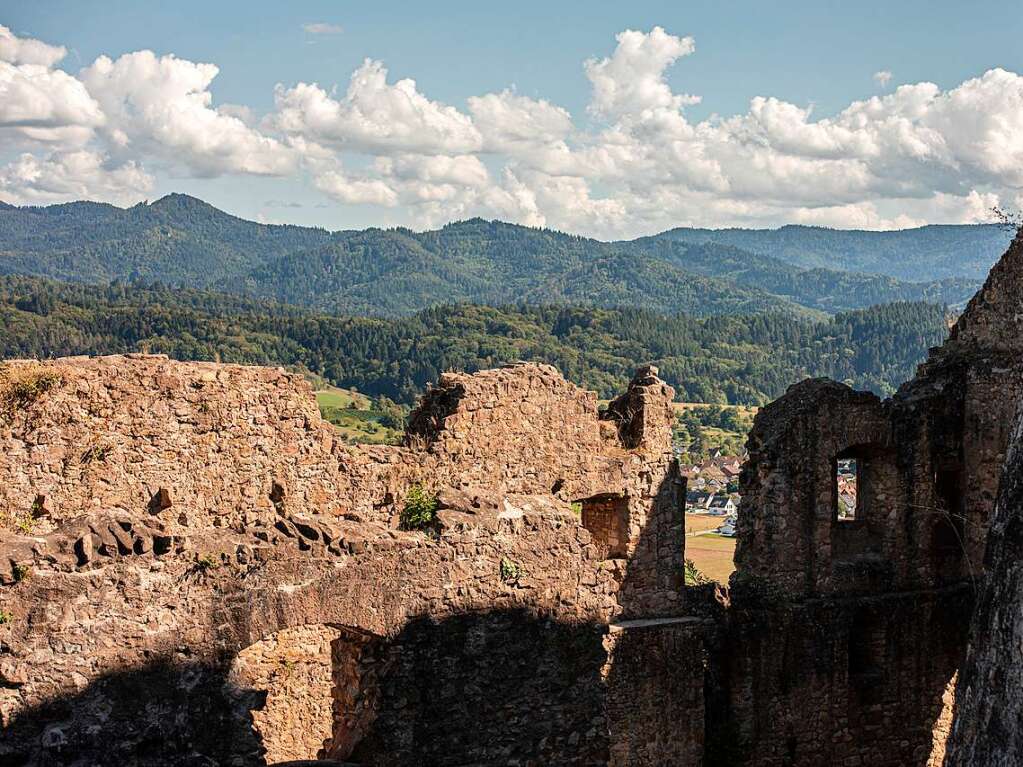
0, 276, 946, 404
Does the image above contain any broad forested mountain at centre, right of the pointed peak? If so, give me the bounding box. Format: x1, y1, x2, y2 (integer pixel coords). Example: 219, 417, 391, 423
224, 219, 814, 317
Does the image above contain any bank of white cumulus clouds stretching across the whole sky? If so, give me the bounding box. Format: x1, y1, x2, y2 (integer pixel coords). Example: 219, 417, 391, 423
0, 22, 1023, 237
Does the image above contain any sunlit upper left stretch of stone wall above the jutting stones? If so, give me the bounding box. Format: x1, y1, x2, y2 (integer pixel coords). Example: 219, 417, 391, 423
0, 356, 351, 531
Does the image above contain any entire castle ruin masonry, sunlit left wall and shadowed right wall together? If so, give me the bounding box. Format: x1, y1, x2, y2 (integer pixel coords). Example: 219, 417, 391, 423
6, 241, 1023, 767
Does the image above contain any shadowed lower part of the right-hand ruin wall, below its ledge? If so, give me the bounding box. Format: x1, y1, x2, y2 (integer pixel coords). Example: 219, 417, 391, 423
728, 589, 971, 767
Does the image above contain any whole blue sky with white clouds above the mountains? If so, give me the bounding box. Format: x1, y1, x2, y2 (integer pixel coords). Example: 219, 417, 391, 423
0, 0, 1023, 238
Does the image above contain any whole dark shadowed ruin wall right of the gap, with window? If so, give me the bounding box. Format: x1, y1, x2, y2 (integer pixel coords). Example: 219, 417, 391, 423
729, 234, 1023, 766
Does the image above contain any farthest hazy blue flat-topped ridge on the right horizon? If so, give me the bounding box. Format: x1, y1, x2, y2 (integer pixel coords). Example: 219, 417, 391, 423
658, 224, 1013, 280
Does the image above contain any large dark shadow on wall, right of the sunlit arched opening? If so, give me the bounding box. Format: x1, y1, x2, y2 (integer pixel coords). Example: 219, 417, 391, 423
339, 611, 608, 766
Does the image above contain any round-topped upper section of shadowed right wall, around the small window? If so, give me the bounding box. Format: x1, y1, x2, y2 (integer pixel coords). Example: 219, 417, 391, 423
736, 379, 898, 598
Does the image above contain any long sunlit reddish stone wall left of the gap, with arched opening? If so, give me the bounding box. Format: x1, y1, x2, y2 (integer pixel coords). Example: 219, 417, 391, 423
0, 356, 700, 765
